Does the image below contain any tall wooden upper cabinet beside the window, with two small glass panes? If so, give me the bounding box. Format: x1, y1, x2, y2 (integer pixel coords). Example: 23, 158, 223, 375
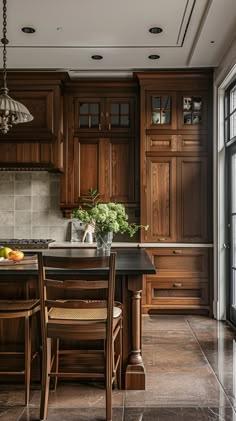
137, 71, 213, 243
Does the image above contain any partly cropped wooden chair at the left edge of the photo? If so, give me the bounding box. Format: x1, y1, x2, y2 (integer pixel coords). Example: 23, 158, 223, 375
0, 282, 40, 405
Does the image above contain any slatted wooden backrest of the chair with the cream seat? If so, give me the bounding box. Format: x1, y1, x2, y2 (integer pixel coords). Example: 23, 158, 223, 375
38, 253, 116, 331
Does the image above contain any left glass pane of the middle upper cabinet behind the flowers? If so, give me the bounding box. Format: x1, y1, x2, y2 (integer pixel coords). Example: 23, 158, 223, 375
79, 102, 100, 129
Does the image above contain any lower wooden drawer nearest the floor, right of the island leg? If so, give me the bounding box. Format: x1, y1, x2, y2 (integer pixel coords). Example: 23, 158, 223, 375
146, 278, 209, 307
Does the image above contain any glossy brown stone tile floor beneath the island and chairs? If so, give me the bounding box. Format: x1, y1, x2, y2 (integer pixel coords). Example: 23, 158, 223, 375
0, 315, 236, 421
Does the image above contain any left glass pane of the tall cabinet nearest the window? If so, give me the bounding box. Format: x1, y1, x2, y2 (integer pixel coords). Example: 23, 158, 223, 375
151, 95, 171, 125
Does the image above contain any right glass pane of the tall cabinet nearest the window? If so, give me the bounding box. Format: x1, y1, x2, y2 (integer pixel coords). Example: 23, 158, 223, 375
182, 96, 202, 126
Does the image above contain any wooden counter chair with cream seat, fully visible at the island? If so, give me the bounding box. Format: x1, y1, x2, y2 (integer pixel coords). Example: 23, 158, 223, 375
39, 253, 122, 421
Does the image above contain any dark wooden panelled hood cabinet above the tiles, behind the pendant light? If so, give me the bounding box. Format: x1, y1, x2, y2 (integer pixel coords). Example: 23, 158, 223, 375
0, 72, 65, 170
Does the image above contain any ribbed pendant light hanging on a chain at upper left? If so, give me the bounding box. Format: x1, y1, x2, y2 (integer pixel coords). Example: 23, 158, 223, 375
0, 0, 34, 134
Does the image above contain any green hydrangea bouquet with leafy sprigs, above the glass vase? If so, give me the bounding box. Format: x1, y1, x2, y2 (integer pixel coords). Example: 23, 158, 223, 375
71, 188, 148, 237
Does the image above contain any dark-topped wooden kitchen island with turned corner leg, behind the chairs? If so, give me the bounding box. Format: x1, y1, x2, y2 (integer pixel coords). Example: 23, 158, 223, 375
0, 248, 156, 390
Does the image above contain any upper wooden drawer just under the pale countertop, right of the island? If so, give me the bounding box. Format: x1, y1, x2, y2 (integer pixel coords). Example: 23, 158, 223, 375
147, 247, 209, 279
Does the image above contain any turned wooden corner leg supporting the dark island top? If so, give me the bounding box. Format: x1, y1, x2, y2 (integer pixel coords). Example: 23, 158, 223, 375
125, 276, 145, 390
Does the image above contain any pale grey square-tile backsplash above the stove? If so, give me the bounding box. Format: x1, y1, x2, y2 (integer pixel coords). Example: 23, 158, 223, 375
0, 171, 69, 241
